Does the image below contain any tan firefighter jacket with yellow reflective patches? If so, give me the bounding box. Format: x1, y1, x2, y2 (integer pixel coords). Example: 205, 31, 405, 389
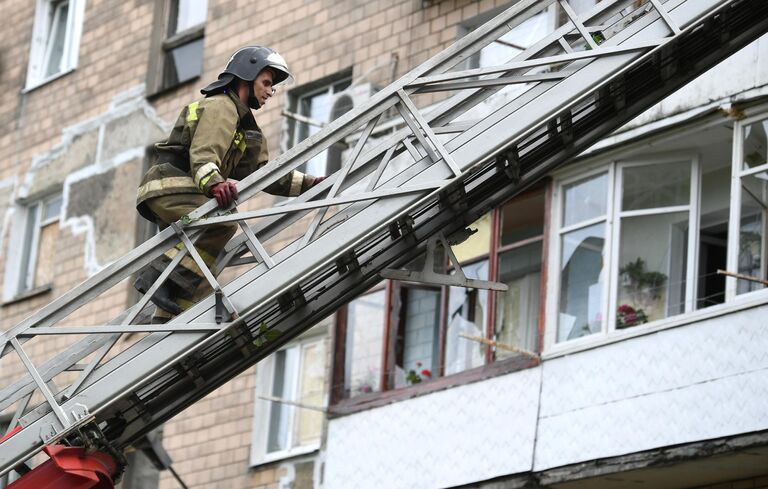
136, 92, 315, 221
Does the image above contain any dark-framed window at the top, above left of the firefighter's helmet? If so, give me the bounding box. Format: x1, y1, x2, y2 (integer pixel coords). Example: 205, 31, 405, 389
147, 0, 208, 94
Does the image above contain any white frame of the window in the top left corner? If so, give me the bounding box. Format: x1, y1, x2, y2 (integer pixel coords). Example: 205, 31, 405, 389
24, 0, 85, 91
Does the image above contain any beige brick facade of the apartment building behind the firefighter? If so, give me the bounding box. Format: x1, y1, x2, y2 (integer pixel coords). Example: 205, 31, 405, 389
0, 0, 508, 489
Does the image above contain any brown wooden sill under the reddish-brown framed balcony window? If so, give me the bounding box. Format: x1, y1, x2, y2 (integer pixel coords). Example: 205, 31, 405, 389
328, 355, 541, 419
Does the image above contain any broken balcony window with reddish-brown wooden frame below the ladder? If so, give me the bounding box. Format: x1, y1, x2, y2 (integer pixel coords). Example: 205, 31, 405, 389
334, 188, 546, 402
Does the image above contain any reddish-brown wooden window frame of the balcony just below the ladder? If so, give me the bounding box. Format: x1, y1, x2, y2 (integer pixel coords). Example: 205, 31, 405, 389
328, 179, 553, 418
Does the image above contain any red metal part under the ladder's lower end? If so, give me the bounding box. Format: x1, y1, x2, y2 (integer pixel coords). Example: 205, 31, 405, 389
8, 445, 117, 489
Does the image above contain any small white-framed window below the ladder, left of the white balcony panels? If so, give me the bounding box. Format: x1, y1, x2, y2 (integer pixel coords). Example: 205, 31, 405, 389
251, 334, 326, 465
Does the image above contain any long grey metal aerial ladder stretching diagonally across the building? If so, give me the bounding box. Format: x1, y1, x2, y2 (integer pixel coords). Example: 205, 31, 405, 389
0, 0, 768, 489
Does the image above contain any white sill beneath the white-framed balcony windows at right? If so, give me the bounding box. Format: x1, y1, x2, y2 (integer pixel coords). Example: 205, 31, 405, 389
541, 289, 768, 360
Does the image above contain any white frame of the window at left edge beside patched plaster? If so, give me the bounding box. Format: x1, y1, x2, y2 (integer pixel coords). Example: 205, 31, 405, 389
3, 194, 63, 302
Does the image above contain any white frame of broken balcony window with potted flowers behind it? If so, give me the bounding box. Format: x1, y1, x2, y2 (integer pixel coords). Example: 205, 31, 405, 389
545, 152, 704, 354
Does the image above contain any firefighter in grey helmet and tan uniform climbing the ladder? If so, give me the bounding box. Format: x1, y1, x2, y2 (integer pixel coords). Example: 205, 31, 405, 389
134, 46, 325, 323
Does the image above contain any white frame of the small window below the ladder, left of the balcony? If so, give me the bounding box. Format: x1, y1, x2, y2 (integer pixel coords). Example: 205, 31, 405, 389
250, 326, 328, 466
